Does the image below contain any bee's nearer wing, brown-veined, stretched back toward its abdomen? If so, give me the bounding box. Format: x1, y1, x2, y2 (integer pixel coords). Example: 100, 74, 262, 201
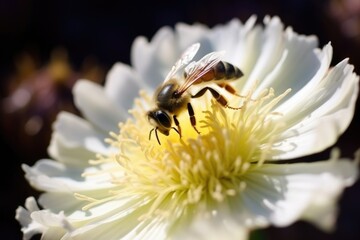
178, 51, 225, 95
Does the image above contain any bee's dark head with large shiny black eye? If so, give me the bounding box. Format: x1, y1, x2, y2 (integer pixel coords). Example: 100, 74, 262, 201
147, 109, 172, 136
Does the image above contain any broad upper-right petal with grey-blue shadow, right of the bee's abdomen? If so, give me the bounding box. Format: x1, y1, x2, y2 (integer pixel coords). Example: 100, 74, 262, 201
255, 28, 320, 101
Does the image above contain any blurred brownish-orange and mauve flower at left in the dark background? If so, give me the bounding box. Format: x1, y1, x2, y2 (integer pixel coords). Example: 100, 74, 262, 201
1, 48, 103, 158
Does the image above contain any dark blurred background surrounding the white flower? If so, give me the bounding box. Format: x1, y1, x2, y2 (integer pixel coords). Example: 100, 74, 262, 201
0, 0, 360, 240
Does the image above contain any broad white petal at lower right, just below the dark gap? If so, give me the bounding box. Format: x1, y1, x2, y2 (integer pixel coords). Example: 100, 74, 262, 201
242, 154, 358, 230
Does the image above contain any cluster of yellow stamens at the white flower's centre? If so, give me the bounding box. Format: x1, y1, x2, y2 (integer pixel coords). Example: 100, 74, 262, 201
75, 86, 290, 220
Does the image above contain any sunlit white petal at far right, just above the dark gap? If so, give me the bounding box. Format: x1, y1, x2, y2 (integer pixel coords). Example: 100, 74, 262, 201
273, 60, 359, 159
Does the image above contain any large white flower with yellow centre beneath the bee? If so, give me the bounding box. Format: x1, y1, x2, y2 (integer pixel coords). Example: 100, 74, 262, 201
16, 17, 359, 239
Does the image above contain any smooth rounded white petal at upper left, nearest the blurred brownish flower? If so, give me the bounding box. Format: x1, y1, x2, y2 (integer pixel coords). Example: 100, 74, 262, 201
73, 80, 127, 132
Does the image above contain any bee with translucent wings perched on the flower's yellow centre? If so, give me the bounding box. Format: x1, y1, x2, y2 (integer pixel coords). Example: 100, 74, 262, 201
147, 43, 243, 145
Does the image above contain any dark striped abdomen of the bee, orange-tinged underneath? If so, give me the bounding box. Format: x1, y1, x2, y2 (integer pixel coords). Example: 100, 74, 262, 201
209, 61, 244, 80
